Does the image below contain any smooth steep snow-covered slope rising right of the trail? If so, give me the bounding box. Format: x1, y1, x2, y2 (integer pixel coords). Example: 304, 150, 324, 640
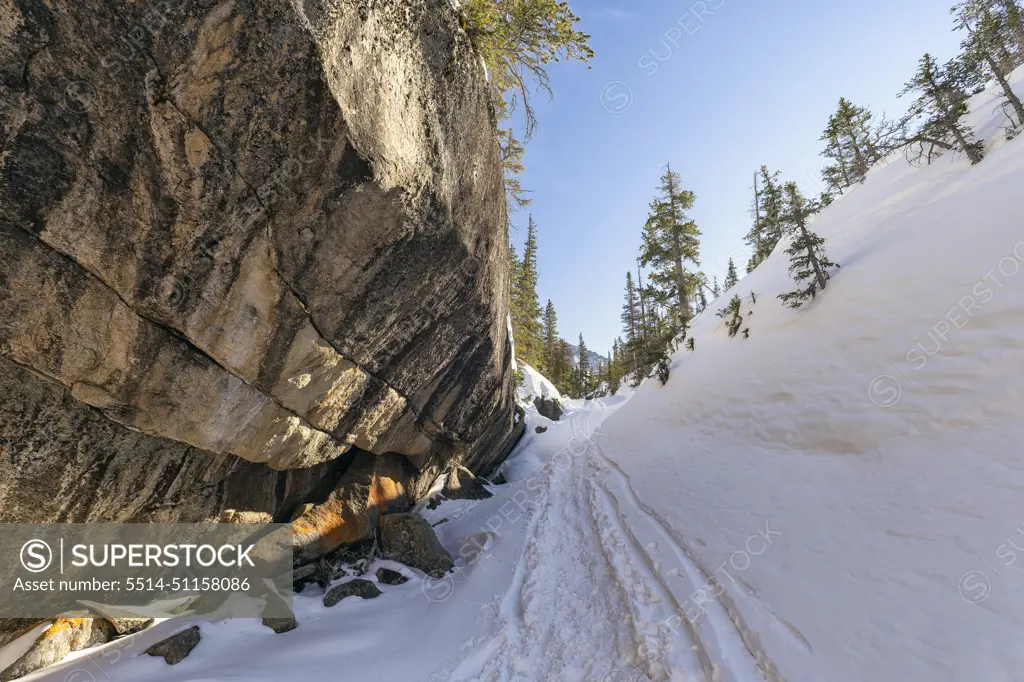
599, 65, 1024, 682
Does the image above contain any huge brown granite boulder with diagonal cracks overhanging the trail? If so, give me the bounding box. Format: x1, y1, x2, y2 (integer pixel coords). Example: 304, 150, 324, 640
0, 0, 521, 524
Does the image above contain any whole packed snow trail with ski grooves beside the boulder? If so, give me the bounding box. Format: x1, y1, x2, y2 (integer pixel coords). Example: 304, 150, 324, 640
468, 402, 779, 682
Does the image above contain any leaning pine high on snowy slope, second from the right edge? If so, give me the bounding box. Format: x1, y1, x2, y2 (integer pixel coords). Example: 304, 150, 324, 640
900, 54, 984, 164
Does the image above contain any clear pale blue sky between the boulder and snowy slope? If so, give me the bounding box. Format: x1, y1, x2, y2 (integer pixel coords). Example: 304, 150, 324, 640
512, 0, 961, 353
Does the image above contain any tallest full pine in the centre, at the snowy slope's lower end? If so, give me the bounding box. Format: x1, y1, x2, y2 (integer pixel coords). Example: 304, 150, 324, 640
640, 165, 700, 331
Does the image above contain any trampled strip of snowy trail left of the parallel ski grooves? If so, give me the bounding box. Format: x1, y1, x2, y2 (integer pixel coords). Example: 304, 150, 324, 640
460, 403, 648, 682
